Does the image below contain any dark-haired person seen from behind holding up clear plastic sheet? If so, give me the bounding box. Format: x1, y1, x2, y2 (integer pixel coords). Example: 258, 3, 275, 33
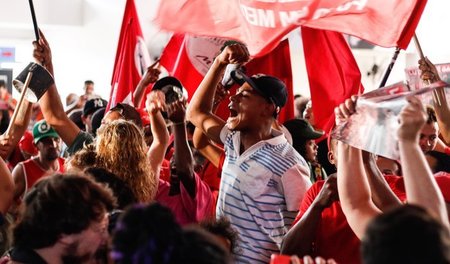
335, 96, 450, 263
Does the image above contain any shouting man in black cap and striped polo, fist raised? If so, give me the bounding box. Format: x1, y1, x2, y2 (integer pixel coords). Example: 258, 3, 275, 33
188, 44, 311, 263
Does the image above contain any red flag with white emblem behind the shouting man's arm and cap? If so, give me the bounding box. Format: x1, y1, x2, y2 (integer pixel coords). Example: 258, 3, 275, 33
160, 34, 294, 122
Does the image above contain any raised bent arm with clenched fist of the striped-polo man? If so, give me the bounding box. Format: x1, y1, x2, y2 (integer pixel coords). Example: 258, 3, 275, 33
187, 44, 249, 143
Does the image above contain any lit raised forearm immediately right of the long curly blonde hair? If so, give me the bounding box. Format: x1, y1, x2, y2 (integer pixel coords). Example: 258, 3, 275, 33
145, 91, 169, 175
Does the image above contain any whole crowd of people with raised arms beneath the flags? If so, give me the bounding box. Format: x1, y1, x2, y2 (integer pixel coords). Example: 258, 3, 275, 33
0, 29, 450, 264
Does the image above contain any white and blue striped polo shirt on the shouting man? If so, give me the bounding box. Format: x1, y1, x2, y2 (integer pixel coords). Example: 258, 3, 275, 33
216, 127, 311, 263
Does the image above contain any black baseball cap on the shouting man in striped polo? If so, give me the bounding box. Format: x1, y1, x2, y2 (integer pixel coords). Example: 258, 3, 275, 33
231, 70, 288, 108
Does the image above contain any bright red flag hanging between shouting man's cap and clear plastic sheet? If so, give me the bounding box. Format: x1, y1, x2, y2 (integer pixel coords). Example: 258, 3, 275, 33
301, 28, 364, 135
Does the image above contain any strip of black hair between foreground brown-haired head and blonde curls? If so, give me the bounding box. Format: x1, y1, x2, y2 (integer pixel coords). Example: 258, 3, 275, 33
84, 167, 137, 209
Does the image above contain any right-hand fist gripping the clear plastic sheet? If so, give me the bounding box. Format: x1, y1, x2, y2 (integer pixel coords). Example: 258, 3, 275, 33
397, 96, 427, 142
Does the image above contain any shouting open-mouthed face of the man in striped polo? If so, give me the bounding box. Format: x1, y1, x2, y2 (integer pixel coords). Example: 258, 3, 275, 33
226, 83, 274, 131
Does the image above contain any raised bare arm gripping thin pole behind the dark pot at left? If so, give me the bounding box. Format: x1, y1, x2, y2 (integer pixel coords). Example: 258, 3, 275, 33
33, 31, 80, 146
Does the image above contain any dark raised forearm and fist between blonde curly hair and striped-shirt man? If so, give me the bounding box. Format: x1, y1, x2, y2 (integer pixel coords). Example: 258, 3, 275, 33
167, 99, 196, 198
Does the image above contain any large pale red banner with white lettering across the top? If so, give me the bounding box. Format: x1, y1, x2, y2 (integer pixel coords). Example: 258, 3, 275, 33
155, 0, 427, 56
